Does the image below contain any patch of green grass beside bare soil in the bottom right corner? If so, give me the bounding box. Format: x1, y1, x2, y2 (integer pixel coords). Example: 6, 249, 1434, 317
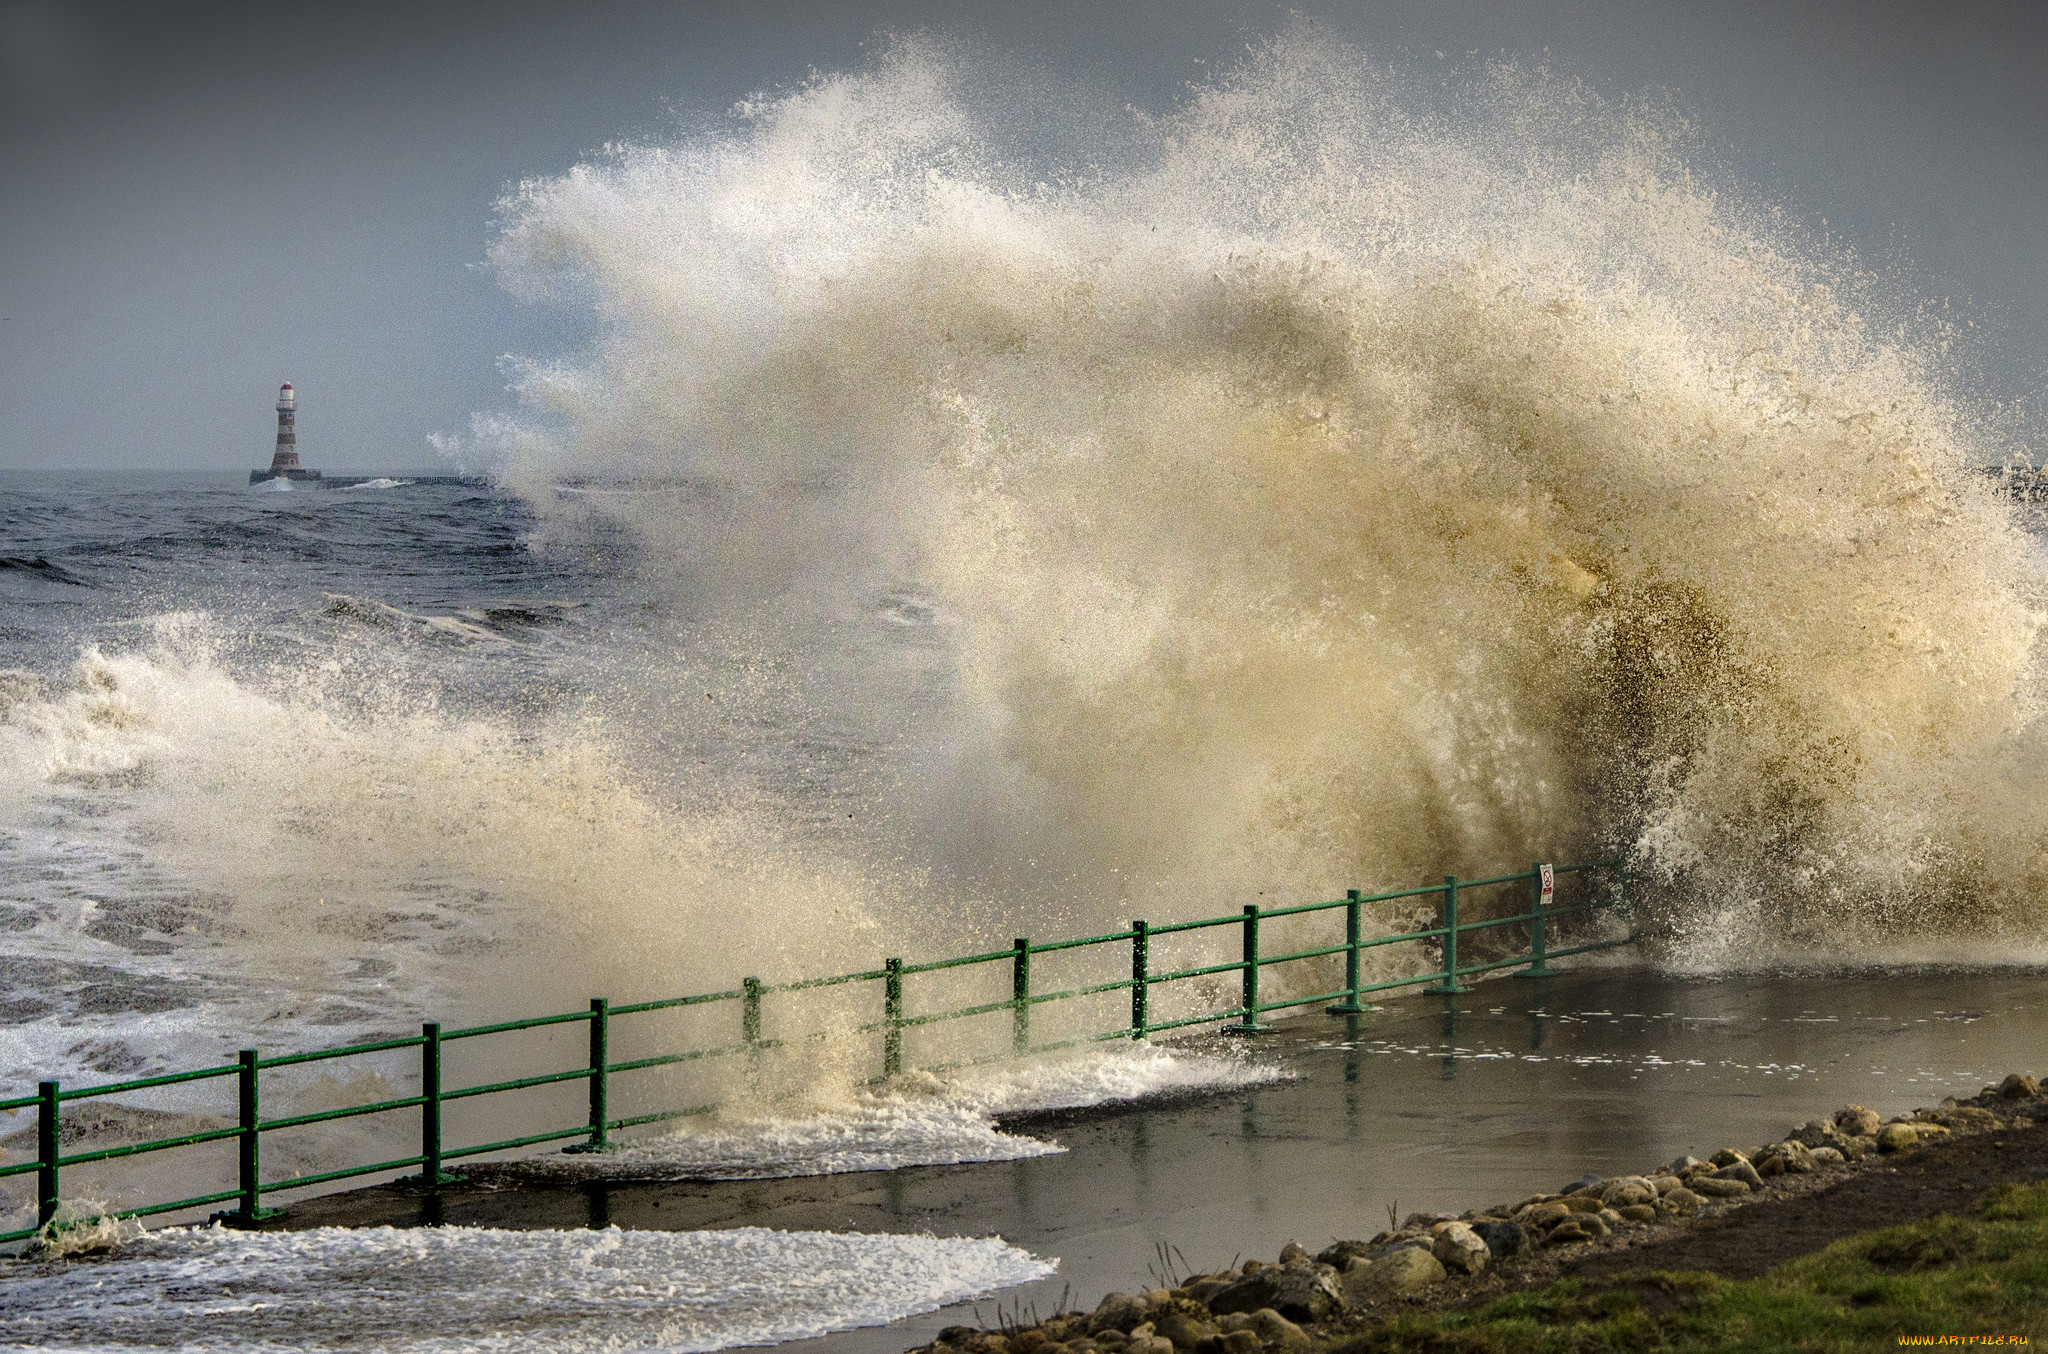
1325, 1184, 2048, 1354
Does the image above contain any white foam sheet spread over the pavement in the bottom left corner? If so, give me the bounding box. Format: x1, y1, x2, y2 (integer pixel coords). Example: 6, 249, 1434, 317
0, 1227, 1059, 1354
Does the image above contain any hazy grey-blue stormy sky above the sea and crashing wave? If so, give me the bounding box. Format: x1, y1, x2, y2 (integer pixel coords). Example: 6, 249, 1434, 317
0, 0, 2048, 471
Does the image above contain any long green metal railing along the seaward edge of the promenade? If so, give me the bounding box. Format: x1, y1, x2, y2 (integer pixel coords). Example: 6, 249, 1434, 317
0, 860, 1628, 1241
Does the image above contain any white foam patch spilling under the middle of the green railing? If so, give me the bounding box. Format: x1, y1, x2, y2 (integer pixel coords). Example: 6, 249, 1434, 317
526, 1043, 1292, 1180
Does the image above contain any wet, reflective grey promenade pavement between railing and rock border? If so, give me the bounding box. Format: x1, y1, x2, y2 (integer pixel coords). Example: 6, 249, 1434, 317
272, 971, 2048, 1354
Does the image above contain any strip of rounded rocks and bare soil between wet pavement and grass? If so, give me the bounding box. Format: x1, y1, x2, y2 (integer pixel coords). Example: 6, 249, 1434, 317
911, 1073, 2048, 1354
